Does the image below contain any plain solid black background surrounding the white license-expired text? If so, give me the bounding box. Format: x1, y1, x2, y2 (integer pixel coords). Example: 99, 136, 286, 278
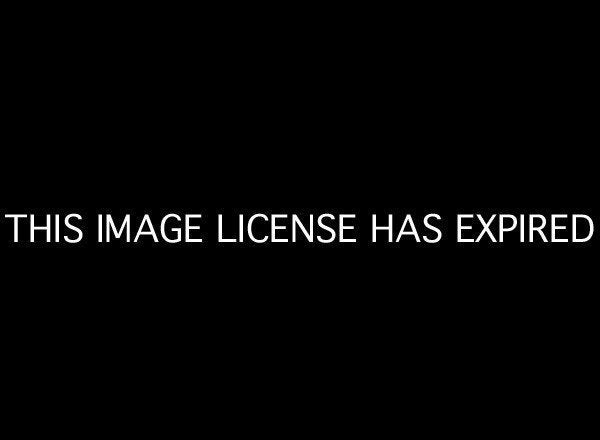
1, 5, 598, 433
